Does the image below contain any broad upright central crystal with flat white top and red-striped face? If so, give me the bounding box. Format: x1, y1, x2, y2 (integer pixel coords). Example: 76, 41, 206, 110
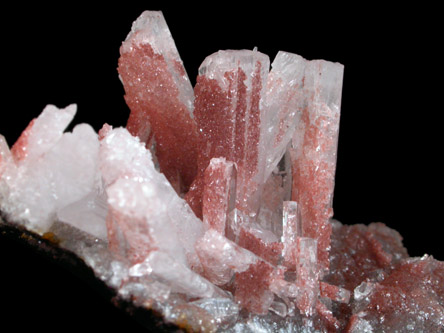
187, 50, 268, 216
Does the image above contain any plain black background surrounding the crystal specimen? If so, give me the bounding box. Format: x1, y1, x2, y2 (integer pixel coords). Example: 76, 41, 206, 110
0, 1, 444, 331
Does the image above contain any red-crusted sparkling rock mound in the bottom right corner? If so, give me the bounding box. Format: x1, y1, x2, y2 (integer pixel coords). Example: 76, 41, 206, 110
346, 256, 444, 332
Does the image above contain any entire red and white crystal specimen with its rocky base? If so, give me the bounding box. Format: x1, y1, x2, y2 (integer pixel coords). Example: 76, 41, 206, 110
0, 11, 444, 332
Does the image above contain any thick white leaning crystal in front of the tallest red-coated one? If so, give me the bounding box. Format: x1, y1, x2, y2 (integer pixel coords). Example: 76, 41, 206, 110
100, 128, 204, 267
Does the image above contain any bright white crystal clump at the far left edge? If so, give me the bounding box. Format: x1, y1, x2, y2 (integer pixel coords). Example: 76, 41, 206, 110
0, 110, 99, 233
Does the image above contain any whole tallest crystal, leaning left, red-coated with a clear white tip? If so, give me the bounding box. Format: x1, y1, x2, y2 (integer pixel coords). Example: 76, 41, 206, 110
118, 11, 199, 192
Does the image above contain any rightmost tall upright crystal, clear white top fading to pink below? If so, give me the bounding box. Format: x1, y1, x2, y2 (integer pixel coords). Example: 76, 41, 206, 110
292, 61, 344, 269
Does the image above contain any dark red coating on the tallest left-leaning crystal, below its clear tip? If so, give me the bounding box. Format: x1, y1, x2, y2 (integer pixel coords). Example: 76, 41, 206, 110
118, 37, 199, 192
